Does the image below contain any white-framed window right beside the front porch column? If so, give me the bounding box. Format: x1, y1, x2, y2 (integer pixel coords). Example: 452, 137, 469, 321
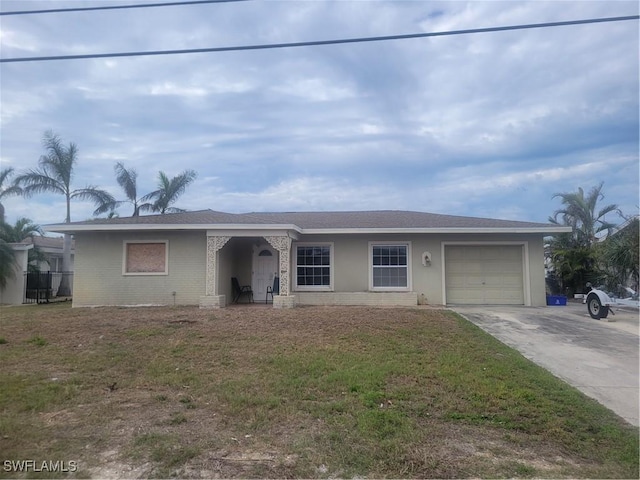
295, 243, 333, 291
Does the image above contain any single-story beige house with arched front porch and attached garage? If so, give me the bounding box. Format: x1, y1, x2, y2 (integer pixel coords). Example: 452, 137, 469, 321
45, 210, 570, 308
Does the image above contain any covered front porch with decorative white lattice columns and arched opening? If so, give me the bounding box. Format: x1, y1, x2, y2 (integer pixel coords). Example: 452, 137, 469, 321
200, 230, 298, 308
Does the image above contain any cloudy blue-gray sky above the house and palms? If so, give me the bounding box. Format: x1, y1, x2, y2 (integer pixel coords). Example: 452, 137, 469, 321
0, 0, 640, 229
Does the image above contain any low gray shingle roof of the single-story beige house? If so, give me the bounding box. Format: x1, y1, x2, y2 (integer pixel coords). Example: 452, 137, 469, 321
48, 210, 557, 231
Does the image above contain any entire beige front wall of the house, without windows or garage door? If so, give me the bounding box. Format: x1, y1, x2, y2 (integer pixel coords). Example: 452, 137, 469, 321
73, 231, 546, 306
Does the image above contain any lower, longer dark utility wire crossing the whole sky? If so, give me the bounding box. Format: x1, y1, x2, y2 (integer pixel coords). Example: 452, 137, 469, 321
0, 15, 640, 63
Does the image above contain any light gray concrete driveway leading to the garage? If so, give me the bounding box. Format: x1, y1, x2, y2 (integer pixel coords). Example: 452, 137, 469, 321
452, 303, 640, 425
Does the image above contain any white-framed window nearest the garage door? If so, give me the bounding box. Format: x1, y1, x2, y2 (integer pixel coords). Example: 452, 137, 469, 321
369, 243, 410, 290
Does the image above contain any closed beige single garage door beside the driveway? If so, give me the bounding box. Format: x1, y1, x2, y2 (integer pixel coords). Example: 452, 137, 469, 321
445, 245, 524, 305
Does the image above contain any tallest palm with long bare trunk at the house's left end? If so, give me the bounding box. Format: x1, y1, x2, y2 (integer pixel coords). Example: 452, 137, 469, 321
15, 130, 115, 296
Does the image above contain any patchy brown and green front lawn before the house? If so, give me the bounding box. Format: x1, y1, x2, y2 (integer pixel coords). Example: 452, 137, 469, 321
0, 305, 638, 478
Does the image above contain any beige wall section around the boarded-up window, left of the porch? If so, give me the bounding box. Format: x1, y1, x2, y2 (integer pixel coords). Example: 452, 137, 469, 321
73, 232, 206, 306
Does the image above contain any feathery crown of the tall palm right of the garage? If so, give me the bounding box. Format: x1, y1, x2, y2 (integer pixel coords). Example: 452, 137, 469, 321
549, 182, 622, 248
